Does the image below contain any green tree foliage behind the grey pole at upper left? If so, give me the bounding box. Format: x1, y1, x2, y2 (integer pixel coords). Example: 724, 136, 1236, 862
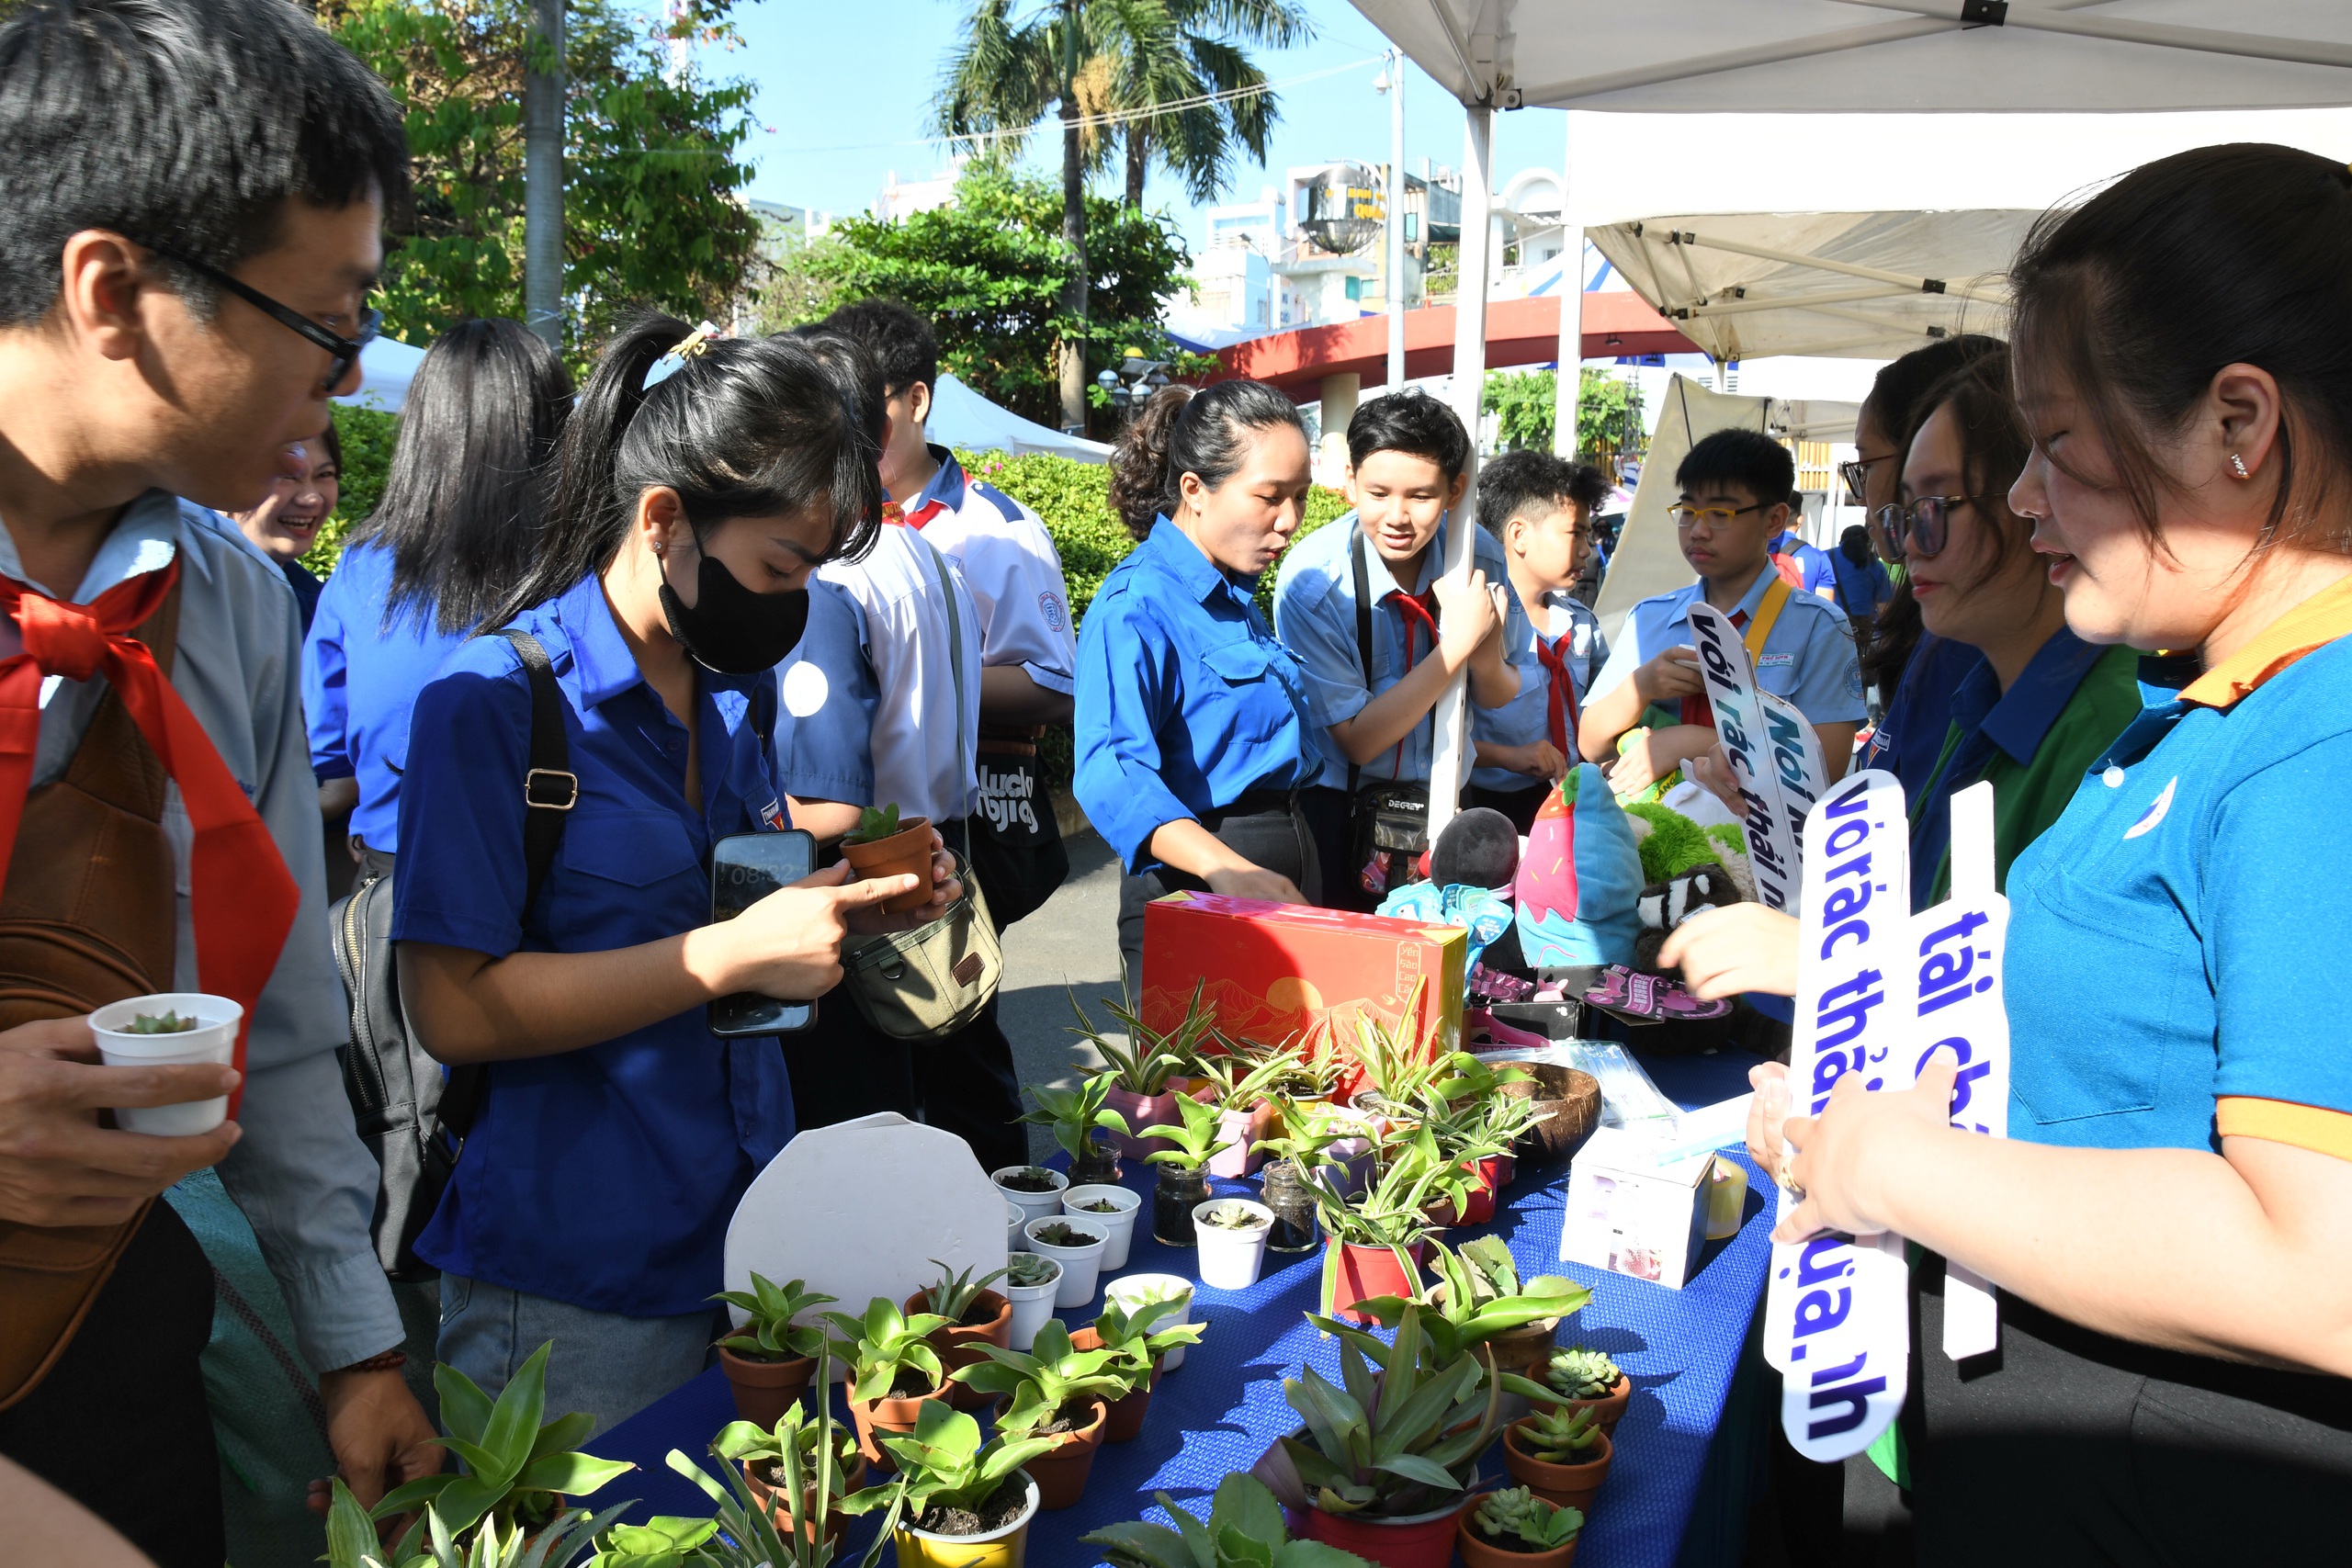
320, 0, 760, 357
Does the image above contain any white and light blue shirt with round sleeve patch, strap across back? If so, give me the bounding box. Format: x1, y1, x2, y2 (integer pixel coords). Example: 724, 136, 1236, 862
776, 525, 981, 823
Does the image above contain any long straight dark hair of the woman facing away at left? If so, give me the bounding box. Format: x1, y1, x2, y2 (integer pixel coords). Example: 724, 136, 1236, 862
353, 320, 571, 637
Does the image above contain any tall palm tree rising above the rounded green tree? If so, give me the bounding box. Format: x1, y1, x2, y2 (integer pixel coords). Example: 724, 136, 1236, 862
933, 0, 1312, 430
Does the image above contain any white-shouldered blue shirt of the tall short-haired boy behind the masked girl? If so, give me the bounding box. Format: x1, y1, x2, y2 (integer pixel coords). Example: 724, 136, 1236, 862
900, 446, 1077, 696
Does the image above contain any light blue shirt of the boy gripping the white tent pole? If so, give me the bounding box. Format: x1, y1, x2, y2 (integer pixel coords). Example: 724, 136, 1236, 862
1275, 513, 1536, 790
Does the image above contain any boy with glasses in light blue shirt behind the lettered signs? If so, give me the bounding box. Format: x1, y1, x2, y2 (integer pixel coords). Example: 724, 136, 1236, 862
1576, 430, 1865, 797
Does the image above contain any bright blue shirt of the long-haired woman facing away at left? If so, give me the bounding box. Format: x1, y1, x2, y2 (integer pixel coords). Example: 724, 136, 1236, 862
301, 546, 481, 853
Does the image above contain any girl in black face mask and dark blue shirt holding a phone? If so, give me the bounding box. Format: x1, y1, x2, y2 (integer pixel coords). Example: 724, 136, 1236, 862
393, 317, 955, 1427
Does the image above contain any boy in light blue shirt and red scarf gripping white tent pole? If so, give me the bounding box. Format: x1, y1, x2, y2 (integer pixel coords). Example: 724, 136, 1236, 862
1275, 390, 1536, 909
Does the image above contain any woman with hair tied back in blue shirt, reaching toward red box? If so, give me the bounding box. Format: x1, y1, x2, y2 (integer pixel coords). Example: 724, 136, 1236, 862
1072, 381, 1322, 999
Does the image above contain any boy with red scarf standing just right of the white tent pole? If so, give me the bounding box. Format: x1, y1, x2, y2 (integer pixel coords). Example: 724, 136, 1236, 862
1470, 451, 1609, 832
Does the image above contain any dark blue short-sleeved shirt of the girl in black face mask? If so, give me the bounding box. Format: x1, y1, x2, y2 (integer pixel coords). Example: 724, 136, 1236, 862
393, 576, 793, 1316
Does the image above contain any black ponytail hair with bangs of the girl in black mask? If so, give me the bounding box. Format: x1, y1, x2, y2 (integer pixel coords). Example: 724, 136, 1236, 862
501, 312, 882, 626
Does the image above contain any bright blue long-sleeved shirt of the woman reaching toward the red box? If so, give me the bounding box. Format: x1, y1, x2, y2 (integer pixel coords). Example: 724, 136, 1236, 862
1072, 517, 1322, 872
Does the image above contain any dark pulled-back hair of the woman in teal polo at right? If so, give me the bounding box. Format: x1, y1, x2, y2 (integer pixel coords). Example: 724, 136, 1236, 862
2008, 141, 2352, 555
